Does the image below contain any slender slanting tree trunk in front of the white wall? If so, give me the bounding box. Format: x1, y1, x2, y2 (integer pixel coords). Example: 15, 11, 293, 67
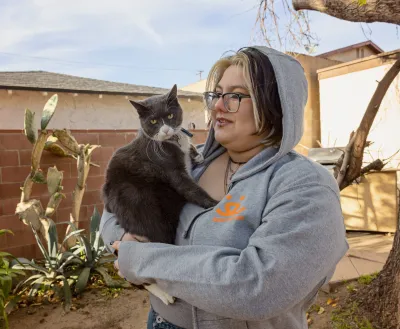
338, 56, 400, 190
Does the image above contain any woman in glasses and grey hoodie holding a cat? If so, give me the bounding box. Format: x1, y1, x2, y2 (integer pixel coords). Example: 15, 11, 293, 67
101, 47, 348, 329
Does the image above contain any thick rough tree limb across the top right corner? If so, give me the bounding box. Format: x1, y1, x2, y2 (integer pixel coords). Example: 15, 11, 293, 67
292, 0, 400, 24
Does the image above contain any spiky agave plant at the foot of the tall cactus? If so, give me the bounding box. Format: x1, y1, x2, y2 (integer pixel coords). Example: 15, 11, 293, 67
13, 208, 129, 311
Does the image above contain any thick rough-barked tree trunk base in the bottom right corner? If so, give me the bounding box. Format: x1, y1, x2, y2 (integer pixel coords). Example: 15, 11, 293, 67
354, 209, 400, 329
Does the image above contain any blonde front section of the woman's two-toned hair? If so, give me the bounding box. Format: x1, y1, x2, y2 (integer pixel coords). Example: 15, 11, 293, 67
206, 50, 282, 145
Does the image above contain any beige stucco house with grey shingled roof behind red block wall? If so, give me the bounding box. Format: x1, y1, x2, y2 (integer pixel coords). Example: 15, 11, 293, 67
0, 71, 206, 130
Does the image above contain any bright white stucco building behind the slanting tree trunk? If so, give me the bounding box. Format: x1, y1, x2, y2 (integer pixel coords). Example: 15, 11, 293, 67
317, 49, 400, 168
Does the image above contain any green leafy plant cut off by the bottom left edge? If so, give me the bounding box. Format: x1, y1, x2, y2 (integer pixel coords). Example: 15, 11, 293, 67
0, 230, 25, 329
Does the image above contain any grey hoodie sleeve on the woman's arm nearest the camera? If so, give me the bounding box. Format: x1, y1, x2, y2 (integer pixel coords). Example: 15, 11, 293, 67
119, 184, 348, 321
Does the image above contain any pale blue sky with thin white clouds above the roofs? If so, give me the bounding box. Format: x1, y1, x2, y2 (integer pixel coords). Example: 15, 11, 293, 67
0, 0, 400, 88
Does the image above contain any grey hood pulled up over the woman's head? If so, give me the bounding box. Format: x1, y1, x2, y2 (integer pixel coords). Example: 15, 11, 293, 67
198, 46, 308, 182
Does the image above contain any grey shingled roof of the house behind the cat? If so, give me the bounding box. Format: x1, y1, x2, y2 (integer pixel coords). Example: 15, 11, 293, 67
0, 71, 201, 97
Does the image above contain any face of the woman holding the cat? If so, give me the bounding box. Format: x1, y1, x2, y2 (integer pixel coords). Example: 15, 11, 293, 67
211, 65, 262, 152
